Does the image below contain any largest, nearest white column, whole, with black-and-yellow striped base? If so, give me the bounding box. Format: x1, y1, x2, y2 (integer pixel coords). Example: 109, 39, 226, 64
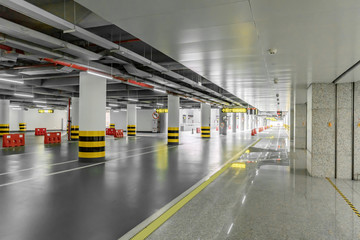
79, 72, 106, 162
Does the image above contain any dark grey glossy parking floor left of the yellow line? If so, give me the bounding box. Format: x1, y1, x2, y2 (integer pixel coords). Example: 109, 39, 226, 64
0, 132, 258, 240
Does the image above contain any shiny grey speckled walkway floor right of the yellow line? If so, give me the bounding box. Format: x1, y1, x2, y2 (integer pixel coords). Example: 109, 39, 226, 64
148, 129, 360, 240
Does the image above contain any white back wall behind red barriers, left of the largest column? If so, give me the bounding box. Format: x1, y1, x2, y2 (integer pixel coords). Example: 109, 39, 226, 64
10, 109, 67, 131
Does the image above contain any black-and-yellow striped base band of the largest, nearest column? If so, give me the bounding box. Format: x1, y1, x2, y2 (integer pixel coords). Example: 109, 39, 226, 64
79, 131, 105, 162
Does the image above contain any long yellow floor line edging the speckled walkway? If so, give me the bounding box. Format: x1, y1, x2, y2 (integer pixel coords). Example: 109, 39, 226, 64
131, 138, 261, 240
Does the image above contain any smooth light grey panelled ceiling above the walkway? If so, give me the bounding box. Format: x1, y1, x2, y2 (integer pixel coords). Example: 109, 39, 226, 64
76, 0, 360, 110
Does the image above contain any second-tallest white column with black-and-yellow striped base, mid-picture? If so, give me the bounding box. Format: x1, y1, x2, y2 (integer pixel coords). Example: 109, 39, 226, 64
168, 94, 180, 145
